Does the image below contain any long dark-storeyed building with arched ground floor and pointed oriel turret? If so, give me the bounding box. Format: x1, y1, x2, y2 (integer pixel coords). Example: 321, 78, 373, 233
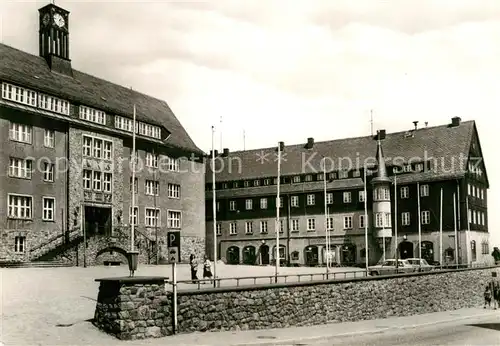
206, 117, 491, 266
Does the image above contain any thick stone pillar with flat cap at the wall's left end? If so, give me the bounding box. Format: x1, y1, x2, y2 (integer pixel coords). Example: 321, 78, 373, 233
93, 276, 173, 340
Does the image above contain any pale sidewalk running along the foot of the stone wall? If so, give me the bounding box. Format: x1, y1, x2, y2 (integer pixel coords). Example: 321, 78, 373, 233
134, 308, 500, 346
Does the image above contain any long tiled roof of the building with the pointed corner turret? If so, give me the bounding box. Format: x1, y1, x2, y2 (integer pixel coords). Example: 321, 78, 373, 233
206, 121, 476, 182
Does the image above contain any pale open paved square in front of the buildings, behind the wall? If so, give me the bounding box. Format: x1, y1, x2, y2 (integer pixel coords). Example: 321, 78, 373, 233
0, 264, 363, 345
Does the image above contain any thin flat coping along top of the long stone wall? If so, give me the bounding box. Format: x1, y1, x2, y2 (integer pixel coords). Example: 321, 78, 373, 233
177, 265, 500, 296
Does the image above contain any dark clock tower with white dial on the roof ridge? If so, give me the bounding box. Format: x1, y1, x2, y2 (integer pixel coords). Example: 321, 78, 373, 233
38, 4, 72, 75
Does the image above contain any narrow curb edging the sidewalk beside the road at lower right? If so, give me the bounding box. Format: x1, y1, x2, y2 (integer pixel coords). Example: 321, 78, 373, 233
231, 312, 498, 346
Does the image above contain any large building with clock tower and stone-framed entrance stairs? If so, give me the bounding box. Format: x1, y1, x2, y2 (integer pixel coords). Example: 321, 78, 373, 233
0, 4, 205, 265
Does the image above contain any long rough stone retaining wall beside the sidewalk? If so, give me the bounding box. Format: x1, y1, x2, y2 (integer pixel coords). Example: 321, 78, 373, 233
96, 267, 500, 338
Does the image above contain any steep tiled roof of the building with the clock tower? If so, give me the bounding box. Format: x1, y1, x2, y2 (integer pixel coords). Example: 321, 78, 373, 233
0, 44, 203, 155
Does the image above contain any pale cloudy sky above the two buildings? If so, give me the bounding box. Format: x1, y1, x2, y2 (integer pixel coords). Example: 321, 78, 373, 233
0, 0, 500, 248
